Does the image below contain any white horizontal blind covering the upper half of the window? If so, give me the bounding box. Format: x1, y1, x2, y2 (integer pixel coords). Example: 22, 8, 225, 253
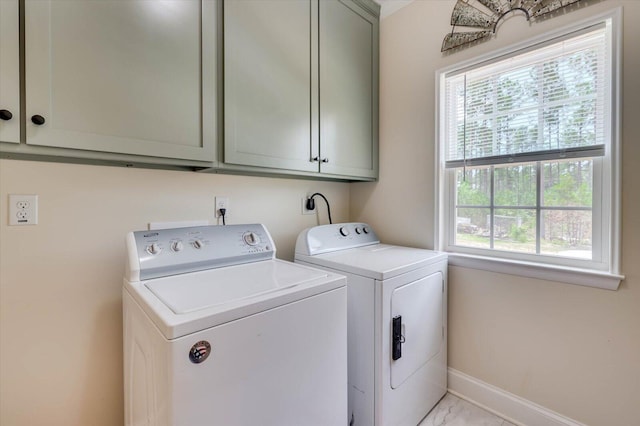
445, 25, 610, 168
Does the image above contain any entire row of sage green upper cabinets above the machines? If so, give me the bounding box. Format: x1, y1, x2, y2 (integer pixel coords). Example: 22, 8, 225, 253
0, 0, 379, 180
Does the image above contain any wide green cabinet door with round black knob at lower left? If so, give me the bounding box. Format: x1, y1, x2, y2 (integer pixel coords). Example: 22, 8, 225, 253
25, 0, 215, 161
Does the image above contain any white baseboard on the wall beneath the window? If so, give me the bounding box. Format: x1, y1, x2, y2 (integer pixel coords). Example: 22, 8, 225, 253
448, 368, 586, 426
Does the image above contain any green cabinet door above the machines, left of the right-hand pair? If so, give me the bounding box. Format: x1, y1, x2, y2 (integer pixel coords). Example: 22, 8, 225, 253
224, 0, 318, 171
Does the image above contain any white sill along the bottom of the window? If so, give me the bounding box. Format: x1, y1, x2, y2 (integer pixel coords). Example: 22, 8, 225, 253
448, 252, 624, 290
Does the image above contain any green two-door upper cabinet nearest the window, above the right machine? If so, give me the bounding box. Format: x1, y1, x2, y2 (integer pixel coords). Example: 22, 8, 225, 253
222, 0, 379, 180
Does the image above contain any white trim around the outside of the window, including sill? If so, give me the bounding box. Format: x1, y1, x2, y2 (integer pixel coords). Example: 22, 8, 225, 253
434, 7, 624, 290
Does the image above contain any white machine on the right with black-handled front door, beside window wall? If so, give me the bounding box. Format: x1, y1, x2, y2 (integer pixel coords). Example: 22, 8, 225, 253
295, 223, 447, 426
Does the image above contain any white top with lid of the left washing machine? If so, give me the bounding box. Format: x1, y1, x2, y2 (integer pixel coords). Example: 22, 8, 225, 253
124, 259, 346, 340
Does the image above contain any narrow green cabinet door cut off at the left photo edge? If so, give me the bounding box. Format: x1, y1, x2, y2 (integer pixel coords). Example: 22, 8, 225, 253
0, 0, 20, 143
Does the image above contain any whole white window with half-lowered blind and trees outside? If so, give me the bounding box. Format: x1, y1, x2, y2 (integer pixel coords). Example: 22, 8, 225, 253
438, 10, 622, 288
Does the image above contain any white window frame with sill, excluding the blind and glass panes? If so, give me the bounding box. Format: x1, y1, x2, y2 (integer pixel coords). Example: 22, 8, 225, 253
435, 7, 624, 290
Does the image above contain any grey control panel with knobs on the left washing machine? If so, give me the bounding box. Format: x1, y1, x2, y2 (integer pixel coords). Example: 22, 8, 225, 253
127, 224, 276, 280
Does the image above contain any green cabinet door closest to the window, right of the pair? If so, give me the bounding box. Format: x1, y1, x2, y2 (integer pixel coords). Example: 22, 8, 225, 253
320, 0, 378, 178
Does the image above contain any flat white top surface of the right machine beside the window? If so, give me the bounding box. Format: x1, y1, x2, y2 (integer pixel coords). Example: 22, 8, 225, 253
296, 244, 447, 280
